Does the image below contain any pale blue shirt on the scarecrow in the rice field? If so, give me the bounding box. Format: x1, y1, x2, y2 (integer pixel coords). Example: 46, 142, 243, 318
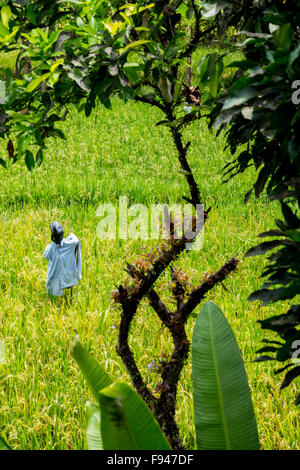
43, 233, 82, 295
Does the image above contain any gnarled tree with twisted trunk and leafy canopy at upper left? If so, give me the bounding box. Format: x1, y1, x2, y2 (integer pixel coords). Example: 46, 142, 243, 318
0, 0, 243, 449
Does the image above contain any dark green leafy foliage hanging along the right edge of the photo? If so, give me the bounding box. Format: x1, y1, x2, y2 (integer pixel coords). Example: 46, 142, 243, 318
202, 0, 300, 404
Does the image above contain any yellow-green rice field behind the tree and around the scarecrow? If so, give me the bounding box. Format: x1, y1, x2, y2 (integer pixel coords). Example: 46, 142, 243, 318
0, 51, 300, 449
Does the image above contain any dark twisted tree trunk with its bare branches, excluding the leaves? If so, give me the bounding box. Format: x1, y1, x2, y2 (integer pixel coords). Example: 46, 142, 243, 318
114, 23, 238, 450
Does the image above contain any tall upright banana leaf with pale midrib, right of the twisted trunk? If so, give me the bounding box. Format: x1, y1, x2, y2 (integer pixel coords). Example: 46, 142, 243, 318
192, 301, 259, 450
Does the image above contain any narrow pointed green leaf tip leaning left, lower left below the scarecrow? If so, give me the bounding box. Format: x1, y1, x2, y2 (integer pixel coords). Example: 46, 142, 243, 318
71, 336, 112, 401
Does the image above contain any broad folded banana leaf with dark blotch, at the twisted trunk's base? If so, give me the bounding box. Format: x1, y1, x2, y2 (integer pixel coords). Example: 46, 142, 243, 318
99, 383, 171, 450
